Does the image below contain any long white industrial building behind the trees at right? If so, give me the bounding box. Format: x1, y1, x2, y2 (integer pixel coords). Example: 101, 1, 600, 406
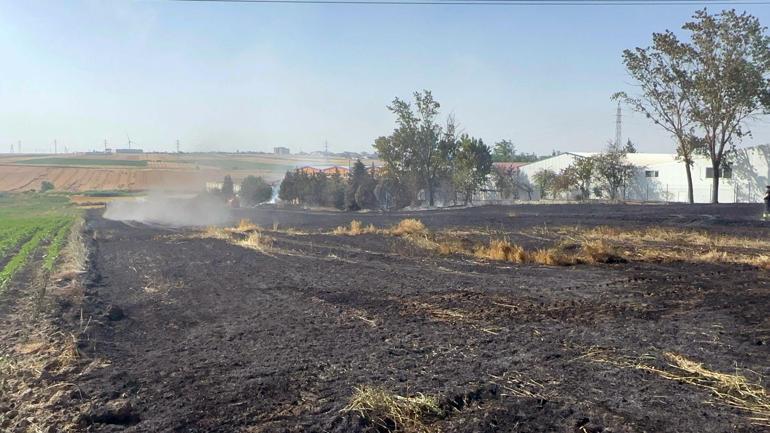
510, 145, 770, 203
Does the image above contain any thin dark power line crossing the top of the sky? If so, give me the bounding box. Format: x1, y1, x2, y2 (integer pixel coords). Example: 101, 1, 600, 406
169, 0, 770, 6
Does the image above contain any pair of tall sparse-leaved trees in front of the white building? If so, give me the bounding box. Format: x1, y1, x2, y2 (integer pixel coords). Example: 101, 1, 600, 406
613, 9, 770, 203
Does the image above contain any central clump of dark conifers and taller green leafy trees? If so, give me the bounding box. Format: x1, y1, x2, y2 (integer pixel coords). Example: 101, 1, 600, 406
279, 90, 539, 210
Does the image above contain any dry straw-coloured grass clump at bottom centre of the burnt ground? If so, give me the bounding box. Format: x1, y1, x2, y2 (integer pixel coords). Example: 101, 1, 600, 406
343, 386, 444, 433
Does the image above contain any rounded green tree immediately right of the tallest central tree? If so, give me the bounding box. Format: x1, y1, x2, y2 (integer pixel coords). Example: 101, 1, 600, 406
452, 134, 492, 204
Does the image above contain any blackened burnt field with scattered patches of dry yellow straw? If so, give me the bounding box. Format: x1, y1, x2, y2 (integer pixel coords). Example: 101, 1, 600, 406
21, 205, 770, 432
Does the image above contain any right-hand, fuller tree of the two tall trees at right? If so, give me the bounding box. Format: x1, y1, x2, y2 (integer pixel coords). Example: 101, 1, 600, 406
683, 9, 770, 203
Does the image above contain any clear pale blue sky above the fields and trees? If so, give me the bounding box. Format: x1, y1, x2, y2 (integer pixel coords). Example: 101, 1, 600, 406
0, 0, 770, 153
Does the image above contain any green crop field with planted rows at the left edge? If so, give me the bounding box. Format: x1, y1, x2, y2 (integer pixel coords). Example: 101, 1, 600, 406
0, 194, 78, 291
